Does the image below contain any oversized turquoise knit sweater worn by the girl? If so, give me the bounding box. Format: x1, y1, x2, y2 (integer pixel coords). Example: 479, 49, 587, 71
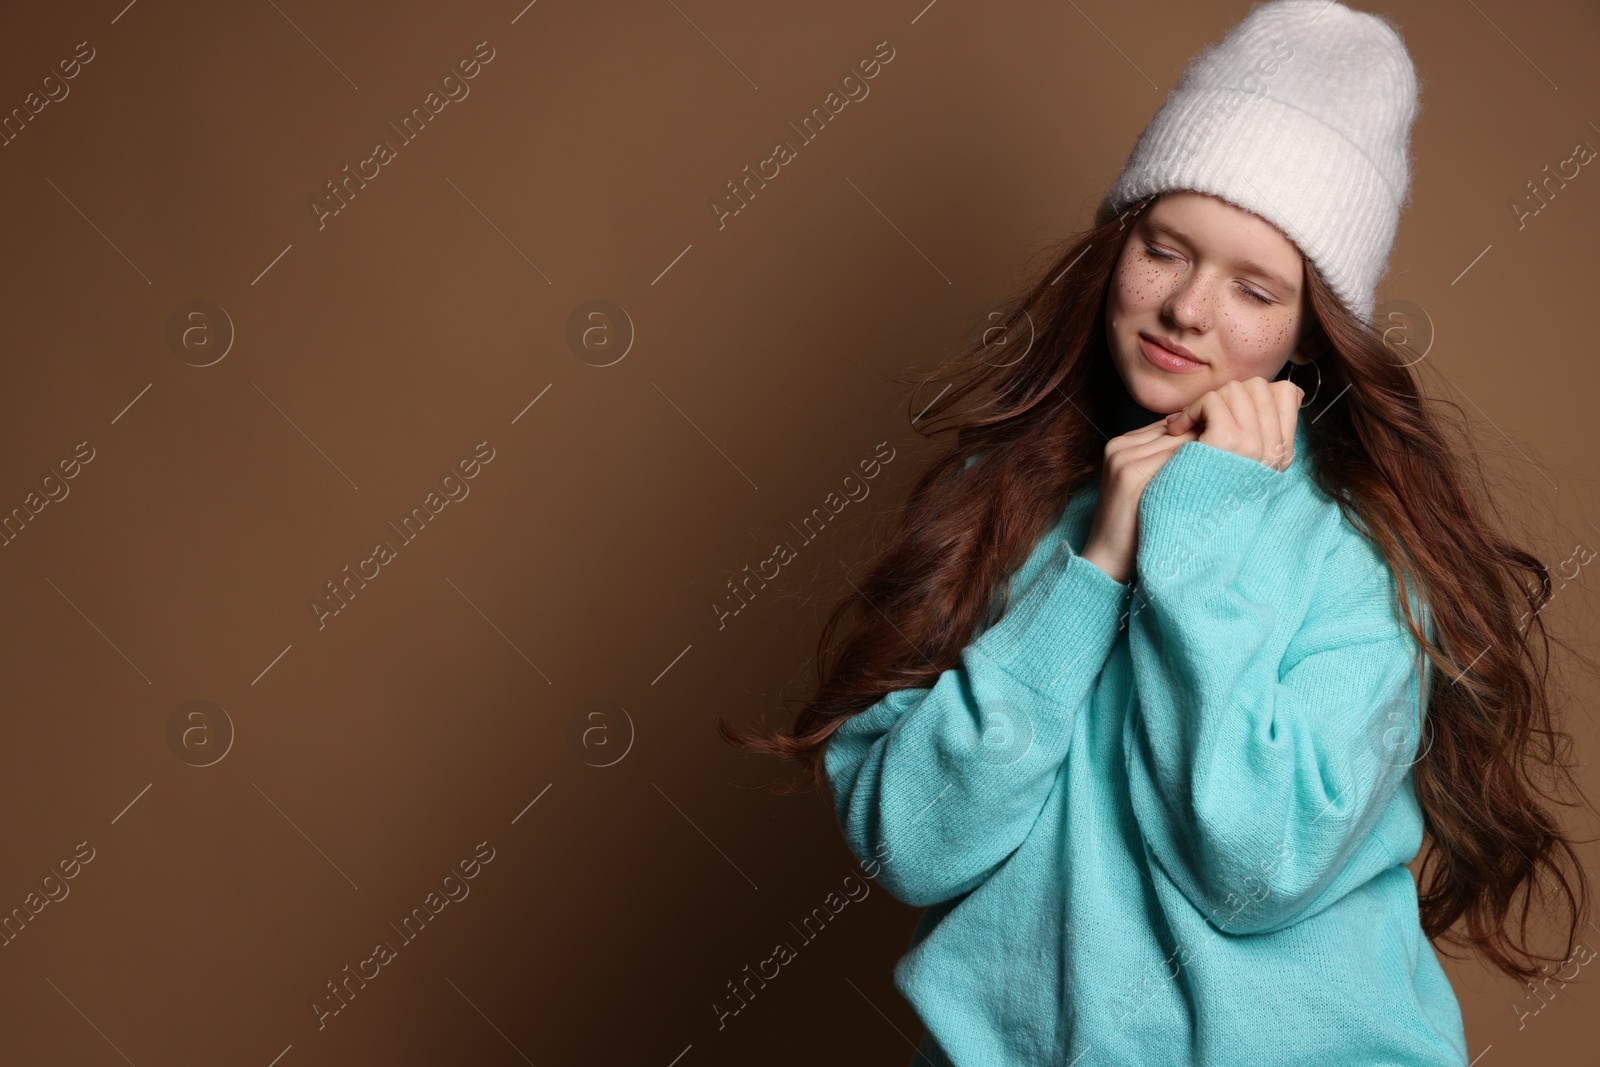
824, 422, 1467, 1067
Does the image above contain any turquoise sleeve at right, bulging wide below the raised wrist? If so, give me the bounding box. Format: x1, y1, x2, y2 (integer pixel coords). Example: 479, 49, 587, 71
1125, 442, 1427, 934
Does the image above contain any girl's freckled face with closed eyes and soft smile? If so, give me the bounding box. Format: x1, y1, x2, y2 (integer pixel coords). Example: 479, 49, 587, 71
1106, 190, 1309, 414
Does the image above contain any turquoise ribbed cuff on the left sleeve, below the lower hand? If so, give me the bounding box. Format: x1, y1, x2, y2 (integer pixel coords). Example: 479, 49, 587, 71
973, 541, 1131, 705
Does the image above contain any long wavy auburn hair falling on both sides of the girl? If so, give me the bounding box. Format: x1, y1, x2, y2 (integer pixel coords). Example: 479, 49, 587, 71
717, 197, 1589, 982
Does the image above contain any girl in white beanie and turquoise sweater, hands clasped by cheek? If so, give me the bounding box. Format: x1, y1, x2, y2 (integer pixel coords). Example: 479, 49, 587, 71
723, 0, 1589, 1067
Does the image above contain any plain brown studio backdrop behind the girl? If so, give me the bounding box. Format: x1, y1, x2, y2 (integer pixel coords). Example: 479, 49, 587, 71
0, 0, 1600, 1067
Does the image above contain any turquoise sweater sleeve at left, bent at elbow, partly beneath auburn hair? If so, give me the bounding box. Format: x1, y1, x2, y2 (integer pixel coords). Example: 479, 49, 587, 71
824, 539, 1130, 907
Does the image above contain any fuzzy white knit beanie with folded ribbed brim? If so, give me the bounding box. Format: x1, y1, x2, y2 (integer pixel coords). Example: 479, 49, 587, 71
1106, 0, 1419, 325
